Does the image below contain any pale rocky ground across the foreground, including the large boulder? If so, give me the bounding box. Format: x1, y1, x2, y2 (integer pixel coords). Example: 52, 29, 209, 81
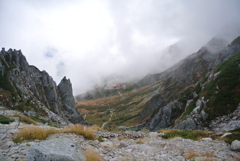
0, 122, 240, 161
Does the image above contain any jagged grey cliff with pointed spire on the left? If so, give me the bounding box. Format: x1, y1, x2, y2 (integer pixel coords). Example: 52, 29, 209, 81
0, 48, 86, 124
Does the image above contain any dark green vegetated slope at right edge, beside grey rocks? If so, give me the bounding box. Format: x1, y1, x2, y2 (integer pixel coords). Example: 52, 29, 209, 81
201, 52, 240, 119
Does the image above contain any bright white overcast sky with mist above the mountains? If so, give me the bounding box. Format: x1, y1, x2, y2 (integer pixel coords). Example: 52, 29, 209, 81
0, 0, 240, 94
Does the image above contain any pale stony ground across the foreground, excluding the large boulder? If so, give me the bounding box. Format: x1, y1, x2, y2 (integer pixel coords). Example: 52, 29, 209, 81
0, 122, 240, 161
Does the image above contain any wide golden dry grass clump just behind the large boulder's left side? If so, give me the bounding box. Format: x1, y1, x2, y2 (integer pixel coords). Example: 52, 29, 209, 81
14, 125, 59, 142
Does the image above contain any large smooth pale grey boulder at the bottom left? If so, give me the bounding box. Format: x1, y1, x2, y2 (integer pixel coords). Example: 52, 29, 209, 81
26, 138, 86, 161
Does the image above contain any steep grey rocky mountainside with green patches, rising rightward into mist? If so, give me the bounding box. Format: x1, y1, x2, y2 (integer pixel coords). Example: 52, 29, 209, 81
143, 37, 240, 131
